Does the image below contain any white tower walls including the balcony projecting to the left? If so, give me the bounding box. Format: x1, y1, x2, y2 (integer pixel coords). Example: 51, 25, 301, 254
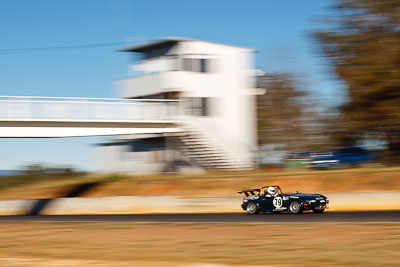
117, 40, 256, 171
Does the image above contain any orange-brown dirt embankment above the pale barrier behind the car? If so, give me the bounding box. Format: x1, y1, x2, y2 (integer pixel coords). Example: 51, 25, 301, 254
0, 169, 400, 200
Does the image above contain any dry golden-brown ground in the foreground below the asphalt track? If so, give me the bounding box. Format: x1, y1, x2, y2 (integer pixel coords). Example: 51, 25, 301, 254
0, 222, 400, 267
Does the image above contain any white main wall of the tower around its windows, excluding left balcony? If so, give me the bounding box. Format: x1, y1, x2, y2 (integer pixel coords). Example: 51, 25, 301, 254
177, 42, 256, 163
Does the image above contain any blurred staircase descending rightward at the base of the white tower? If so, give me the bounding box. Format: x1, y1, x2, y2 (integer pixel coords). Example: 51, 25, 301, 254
177, 125, 252, 171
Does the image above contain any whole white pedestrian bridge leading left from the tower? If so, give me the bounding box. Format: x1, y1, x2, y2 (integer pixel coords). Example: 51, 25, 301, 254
0, 96, 183, 138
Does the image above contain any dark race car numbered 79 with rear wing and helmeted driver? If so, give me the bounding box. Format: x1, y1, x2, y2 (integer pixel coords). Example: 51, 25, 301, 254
237, 185, 329, 214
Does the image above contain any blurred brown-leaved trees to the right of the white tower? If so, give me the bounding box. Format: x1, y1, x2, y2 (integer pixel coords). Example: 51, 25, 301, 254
257, 0, 400, 162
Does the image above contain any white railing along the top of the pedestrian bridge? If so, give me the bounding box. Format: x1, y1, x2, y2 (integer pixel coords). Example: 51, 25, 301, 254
0, 96, 183, 121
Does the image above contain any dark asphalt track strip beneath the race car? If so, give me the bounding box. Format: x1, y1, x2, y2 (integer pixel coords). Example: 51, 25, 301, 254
0, 210, 400, 223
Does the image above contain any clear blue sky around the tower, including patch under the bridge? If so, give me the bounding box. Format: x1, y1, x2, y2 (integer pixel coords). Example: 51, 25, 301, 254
0, 0, 342, 170
